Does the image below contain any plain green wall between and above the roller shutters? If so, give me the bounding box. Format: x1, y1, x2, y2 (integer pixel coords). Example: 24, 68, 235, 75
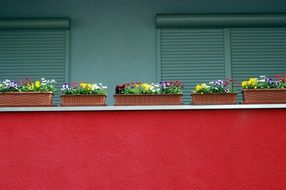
0, 0, 286, 104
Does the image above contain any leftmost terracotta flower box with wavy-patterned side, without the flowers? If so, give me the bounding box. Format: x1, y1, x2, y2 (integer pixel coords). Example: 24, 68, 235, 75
0, 92, 53, 107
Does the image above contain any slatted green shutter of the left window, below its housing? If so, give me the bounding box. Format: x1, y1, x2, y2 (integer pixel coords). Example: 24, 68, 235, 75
0, 29, 69, 103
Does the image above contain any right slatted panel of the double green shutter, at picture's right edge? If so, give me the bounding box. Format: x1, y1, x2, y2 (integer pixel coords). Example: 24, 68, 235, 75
230, 28, 286, 99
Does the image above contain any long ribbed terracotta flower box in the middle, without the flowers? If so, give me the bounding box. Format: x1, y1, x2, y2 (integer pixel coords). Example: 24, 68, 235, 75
114, 94, 183, 106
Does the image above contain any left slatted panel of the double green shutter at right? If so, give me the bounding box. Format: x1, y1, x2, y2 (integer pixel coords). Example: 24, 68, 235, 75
159, 28, 225, 104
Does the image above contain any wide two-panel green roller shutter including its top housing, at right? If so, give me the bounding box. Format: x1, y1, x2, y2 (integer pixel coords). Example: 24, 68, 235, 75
156, 14, 286, 103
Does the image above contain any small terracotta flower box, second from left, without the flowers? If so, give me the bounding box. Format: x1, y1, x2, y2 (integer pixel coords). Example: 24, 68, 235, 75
61, 94, 106, 106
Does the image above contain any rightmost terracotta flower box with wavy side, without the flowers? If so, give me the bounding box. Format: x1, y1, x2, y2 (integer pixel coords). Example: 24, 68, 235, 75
242, 88, 286, 104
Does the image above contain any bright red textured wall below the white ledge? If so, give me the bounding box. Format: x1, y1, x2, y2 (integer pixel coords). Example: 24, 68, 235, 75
0, 109, 286, 190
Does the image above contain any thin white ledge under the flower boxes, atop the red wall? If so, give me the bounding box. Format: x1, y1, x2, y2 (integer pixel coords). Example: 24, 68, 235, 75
0, 104, 286, 112
